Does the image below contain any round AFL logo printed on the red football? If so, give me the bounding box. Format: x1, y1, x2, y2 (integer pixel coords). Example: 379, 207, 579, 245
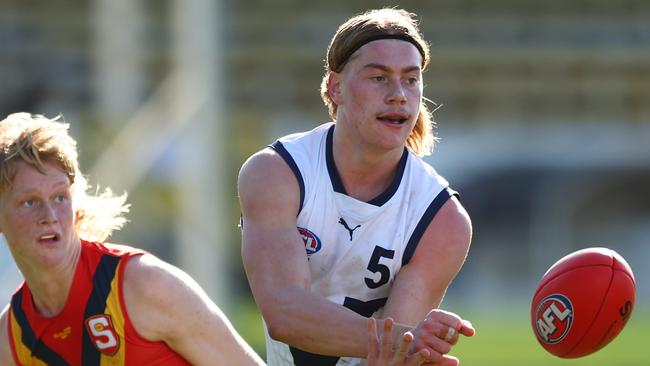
535, 294, 573, 344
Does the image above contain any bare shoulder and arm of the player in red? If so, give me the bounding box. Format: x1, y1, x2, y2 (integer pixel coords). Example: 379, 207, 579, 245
124, 254, 264, 366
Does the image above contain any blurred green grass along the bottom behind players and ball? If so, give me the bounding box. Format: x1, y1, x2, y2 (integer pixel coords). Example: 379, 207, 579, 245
229, 303, 650, 366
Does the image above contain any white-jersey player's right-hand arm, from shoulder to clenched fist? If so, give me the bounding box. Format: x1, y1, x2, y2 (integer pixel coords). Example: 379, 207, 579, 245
382, 197, 475, 364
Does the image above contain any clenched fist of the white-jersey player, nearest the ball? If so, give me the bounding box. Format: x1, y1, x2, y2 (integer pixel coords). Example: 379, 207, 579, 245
409, 309, 476, 366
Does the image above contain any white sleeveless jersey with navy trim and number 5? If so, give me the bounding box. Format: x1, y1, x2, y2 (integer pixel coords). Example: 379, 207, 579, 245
265, 123, 455, 366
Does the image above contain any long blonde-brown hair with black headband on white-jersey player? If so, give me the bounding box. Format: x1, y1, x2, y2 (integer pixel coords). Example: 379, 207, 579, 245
320, 8, 437, 156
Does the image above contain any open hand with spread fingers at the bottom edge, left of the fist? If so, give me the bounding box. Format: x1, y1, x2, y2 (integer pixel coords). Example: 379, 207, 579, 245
366, 318, 429, 366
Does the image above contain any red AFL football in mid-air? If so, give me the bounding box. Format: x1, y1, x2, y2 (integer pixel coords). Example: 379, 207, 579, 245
530, 248, 636, 358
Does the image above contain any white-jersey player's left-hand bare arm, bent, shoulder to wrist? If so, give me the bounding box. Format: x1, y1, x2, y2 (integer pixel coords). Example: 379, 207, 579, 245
238, 149, 367, 357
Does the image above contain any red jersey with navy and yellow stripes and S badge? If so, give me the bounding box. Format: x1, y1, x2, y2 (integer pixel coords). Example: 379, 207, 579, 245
8, 242, 189, 366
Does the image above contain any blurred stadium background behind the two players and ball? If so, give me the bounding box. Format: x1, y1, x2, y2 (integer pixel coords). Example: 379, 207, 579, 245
0, 0, 650, 365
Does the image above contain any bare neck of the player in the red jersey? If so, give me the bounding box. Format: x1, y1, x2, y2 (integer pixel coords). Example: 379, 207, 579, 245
21, 246, 81, 318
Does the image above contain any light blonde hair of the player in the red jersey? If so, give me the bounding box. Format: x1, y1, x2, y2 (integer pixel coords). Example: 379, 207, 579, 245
0, 113, 129, 241
